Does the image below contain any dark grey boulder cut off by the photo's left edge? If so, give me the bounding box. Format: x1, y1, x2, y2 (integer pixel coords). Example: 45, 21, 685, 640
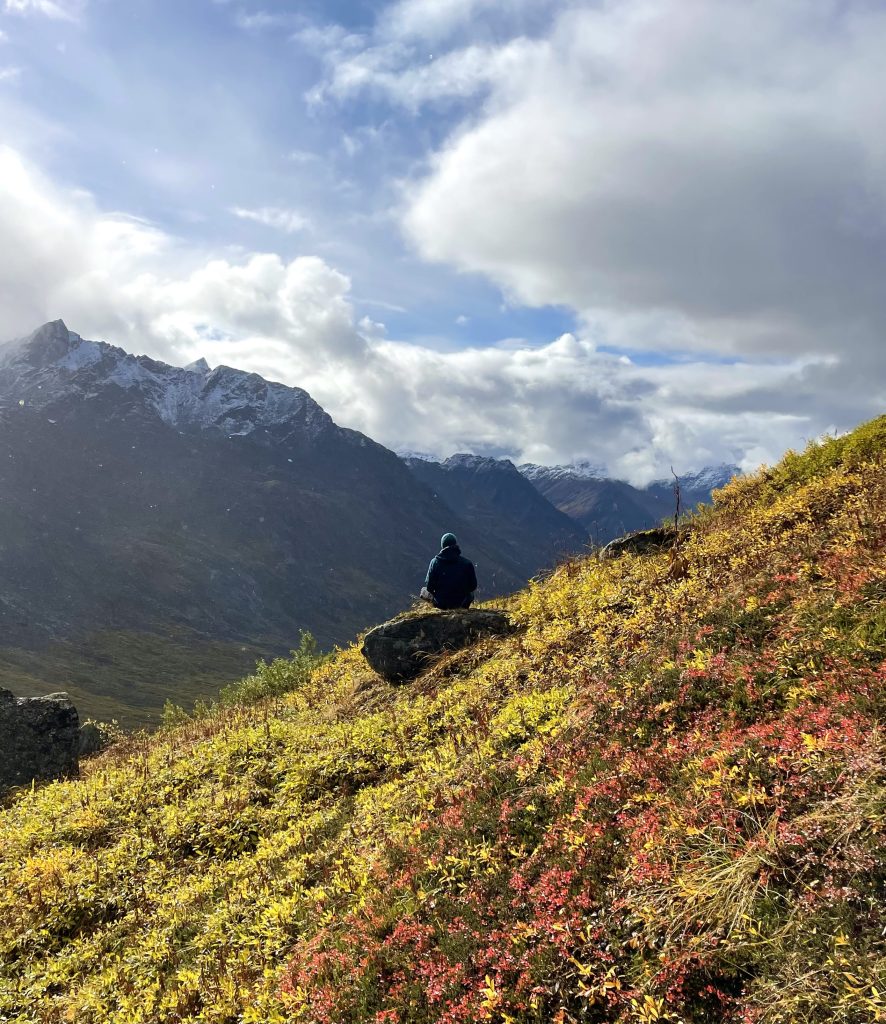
0, 689, 80, 793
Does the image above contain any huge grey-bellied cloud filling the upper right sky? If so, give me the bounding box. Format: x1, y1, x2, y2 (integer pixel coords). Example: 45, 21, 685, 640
399, 0, 886, 373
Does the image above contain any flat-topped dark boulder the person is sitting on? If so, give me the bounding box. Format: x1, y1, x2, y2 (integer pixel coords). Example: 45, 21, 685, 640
363, 608, 514, 683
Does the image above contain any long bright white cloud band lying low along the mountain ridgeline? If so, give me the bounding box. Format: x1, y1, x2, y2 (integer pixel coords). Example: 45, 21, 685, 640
0, 148, 864, 480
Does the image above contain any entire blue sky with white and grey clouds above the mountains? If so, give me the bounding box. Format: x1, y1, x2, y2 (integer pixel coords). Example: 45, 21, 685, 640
0, 0, 886, 483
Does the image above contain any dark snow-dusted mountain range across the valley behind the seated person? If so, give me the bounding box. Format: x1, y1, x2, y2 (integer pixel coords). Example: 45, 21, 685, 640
0, 321, 733, 724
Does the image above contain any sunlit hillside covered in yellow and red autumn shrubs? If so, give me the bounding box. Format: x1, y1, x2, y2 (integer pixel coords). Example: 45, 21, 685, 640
0, 417, 886, 1024
